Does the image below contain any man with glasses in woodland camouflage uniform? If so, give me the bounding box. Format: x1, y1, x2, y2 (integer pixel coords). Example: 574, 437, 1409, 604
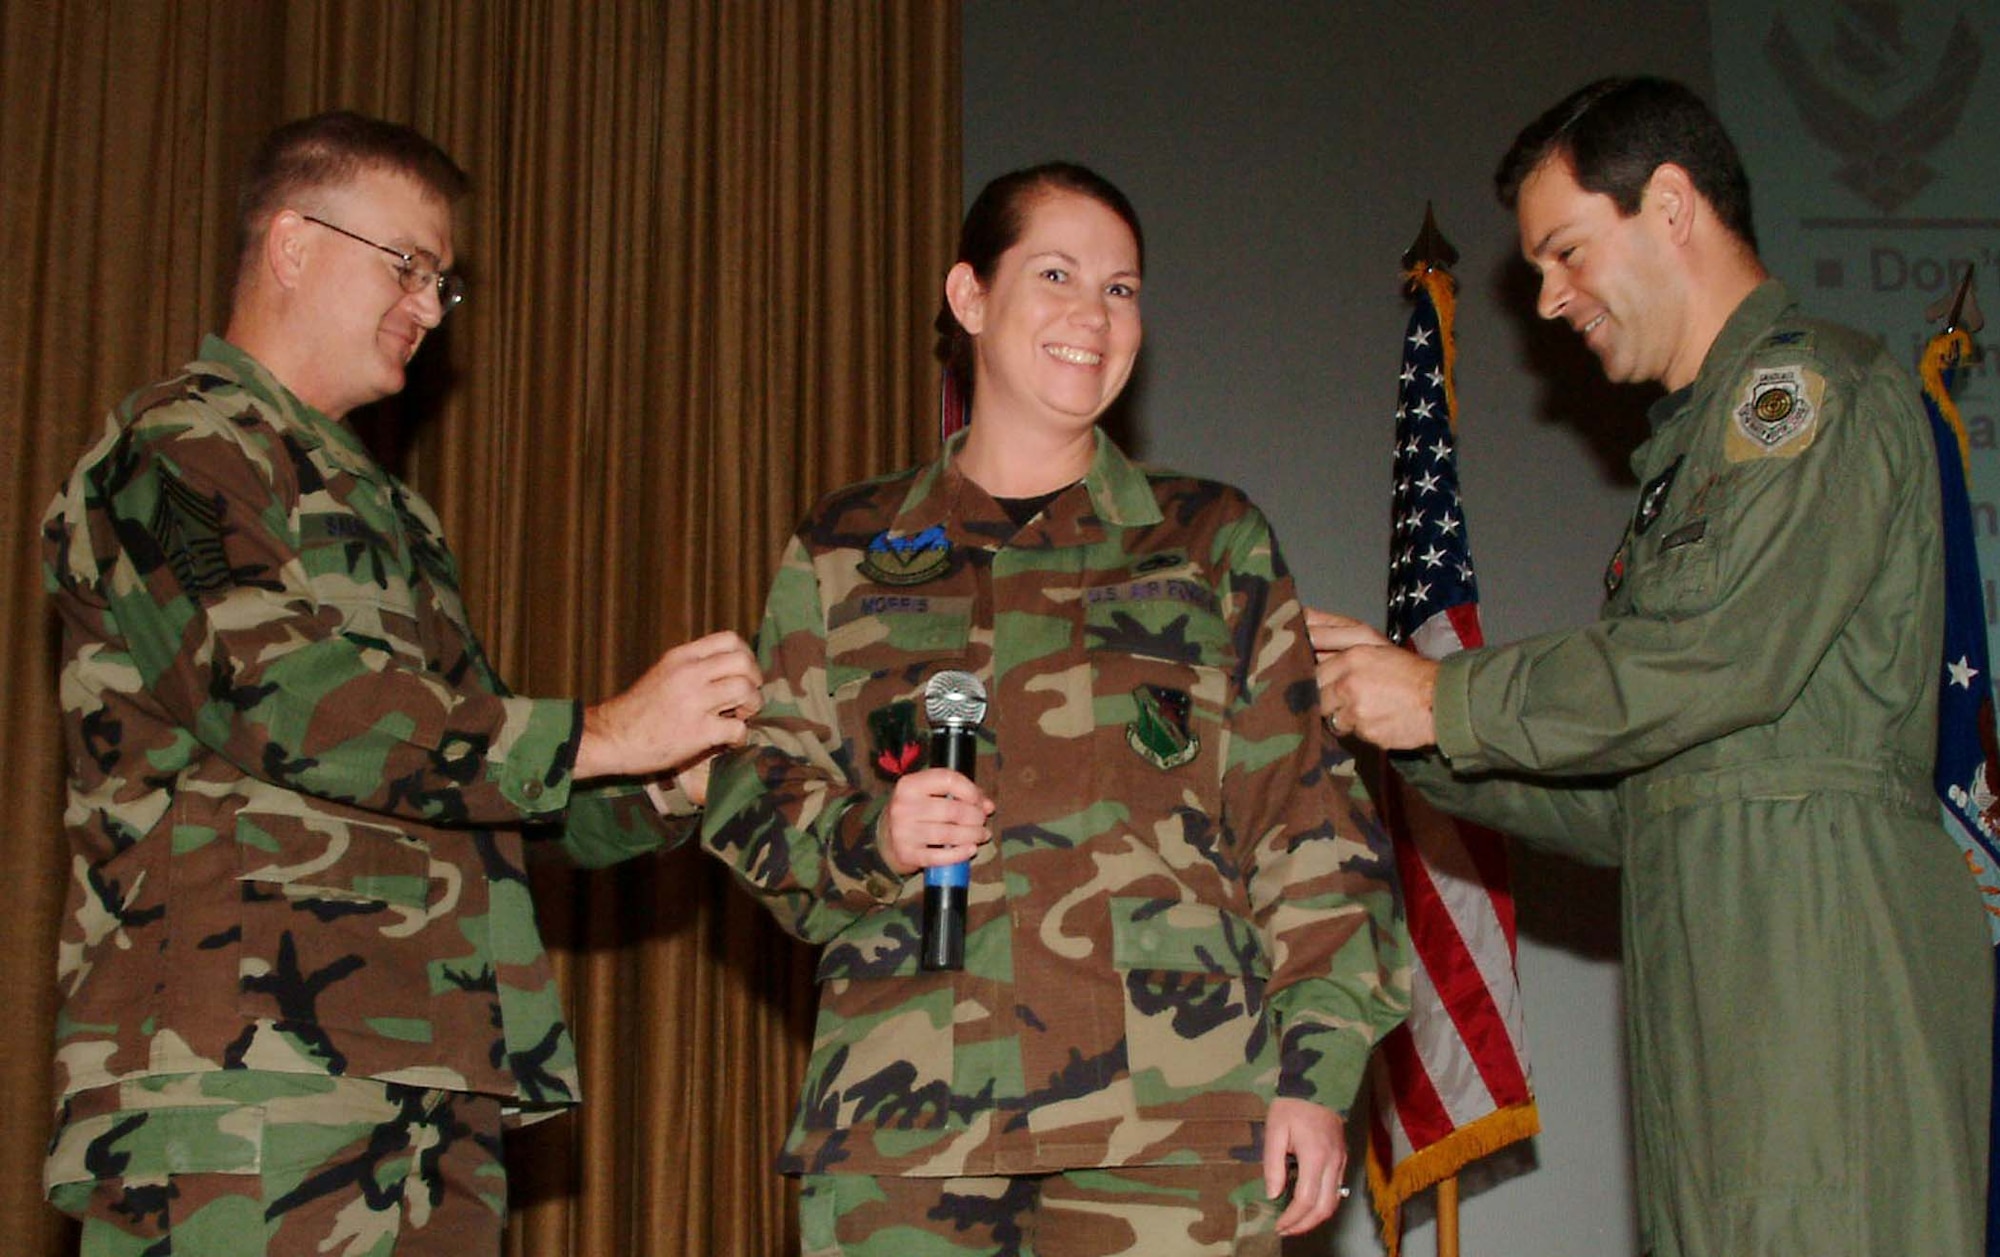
42, 114, 756, 1257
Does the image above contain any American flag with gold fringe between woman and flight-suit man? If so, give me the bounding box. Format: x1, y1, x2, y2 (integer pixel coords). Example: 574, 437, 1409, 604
1368, 264, 1542, 1257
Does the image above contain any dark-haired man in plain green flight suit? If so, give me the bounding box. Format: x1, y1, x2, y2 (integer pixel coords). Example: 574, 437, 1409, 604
1312, 78, 1992, 1257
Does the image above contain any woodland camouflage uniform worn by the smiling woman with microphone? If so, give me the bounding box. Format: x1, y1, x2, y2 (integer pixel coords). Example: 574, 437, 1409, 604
704, 432, 1410, 1255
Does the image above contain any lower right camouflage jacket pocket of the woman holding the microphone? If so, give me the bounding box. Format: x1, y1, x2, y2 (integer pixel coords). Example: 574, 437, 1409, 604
1110, 899, 1278, 1119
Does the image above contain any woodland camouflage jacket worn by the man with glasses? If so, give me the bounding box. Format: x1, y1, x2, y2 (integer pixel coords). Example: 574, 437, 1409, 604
42, 338, 672, 1179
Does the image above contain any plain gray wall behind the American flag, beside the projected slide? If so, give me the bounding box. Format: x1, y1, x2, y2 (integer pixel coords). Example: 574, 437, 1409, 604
964, 0, 1712, 1257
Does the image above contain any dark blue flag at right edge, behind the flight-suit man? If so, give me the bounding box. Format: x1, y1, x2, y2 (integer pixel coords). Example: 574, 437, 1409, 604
1918, 316, 2000, 1257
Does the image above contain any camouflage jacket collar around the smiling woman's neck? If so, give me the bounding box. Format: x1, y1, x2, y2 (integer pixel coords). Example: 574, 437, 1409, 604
890, 430, 1162, 548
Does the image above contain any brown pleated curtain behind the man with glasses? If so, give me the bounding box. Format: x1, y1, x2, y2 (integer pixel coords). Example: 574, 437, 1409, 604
0, 0, 960, 1257
